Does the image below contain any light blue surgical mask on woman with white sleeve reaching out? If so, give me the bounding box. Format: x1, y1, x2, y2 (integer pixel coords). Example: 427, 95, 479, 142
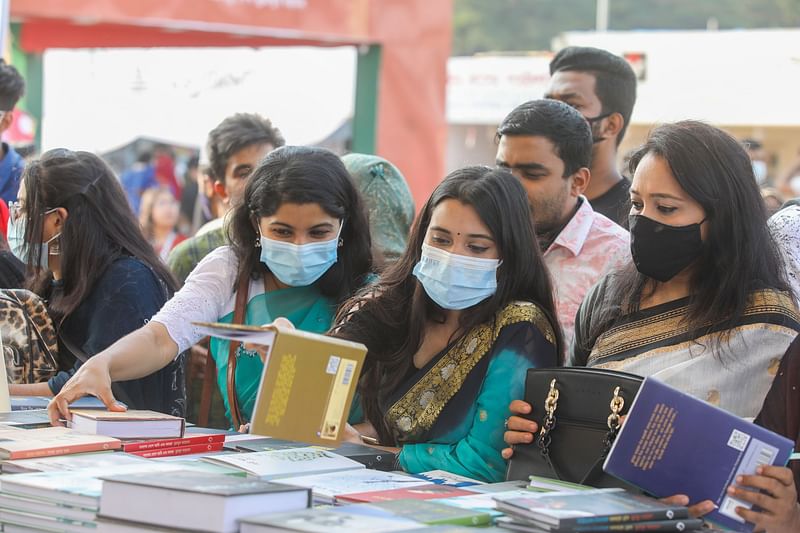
261, 227, 342, 287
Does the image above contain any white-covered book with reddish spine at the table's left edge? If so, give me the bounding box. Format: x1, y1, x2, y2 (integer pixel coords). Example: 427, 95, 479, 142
0, 427, 121, 459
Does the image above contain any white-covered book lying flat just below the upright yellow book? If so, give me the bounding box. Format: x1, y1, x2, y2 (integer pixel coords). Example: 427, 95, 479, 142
202, 446, 364, 479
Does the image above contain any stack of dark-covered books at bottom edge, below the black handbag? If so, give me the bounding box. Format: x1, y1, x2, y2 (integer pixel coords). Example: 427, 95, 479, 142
494, 489, 703, 533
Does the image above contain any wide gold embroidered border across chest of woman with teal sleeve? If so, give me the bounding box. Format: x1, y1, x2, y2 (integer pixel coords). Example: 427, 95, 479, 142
386, 302, 555, 442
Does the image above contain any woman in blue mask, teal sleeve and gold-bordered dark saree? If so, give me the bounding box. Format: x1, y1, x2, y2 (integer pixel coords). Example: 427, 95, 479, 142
332, 167, 561, 481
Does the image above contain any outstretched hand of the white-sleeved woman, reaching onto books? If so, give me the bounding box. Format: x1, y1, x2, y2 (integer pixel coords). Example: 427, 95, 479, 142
47, 357, 127, 426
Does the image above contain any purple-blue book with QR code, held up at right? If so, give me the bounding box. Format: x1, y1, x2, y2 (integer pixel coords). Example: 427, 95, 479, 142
603, 378, 794, 531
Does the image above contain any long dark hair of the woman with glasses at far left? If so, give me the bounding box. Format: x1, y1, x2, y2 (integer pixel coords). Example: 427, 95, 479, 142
22, 148, 177, 318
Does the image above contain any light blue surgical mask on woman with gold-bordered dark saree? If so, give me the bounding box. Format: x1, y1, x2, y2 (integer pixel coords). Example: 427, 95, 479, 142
414, 244, 500, 310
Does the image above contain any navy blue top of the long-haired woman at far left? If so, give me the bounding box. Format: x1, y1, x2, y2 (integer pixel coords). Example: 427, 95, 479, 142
48, 257, 186, 416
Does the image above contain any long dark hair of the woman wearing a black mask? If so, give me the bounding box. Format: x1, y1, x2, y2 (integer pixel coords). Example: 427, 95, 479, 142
581, 120, 791, 351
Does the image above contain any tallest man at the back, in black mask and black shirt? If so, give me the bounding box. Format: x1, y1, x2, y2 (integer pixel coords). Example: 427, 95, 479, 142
545, 46, 636, 228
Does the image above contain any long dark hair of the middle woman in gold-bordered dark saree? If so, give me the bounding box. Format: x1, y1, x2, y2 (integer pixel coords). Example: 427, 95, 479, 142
333, 167, 561, 443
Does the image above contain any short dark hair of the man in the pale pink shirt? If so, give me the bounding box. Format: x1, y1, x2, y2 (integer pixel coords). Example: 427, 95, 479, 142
497, 100, 592, 178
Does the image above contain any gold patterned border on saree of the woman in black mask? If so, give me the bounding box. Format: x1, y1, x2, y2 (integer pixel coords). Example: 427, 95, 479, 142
588, 290, 800, 365
